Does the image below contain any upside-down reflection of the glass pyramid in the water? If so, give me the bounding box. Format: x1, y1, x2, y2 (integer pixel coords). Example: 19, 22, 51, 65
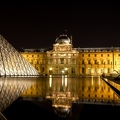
0, 77, 37, 112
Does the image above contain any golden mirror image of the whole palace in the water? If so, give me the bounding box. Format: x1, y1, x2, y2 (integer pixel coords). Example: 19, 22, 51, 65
22, 76, 120, 116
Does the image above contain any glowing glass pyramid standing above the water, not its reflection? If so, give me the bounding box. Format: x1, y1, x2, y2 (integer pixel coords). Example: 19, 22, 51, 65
0, 35, 39, 76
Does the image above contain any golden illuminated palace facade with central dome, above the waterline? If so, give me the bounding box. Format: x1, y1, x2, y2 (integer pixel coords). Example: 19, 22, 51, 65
20, 34, 120, 76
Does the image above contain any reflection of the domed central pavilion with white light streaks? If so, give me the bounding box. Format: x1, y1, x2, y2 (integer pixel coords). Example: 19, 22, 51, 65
46, 76, 78, 117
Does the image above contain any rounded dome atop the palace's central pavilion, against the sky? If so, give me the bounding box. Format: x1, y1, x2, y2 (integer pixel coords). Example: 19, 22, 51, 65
55, 34, 70, 44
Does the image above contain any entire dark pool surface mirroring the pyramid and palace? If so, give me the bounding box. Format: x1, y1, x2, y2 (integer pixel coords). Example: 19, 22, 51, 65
0, 76, 120, 120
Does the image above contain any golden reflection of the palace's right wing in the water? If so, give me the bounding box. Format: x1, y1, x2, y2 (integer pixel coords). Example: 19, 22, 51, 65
79, 77, 120, 103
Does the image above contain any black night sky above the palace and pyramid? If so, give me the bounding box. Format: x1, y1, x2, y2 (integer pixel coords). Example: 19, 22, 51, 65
0, 0, 120, 49
